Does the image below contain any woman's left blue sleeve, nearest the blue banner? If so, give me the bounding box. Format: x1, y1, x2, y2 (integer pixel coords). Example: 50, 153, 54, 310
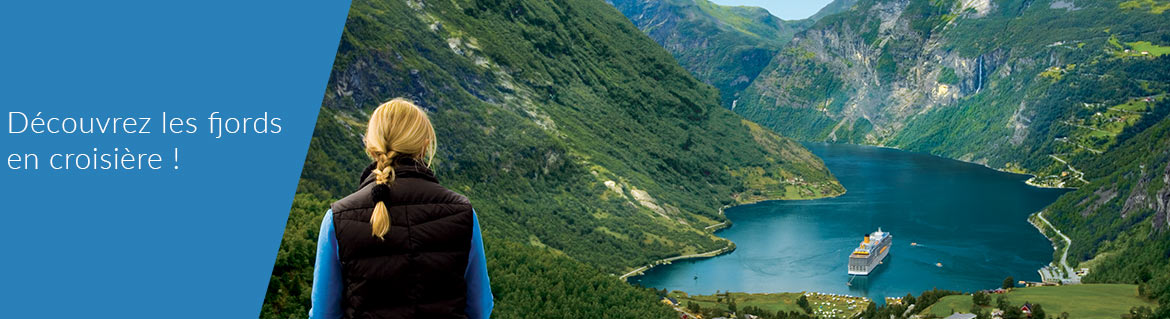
309, 209, 343, 319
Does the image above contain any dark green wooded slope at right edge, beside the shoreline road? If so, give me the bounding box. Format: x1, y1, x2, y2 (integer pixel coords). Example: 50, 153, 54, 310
1045, 100, 1170, 318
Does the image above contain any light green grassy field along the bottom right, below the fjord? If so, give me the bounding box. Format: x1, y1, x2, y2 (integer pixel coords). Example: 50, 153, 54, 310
923, 284, 1154, 318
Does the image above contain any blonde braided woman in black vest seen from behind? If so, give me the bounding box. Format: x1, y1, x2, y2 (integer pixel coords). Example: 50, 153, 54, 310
309, 99, 493, 319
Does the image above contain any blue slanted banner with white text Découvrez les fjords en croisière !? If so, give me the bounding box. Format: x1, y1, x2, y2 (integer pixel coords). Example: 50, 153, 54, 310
0, 1, 350, 318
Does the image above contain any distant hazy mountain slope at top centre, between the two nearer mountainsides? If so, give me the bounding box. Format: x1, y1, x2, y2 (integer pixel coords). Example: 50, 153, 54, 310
608, 0, 811, 108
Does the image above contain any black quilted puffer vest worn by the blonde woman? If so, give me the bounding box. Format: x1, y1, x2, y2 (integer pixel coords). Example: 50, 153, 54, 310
332, 158, 473, 318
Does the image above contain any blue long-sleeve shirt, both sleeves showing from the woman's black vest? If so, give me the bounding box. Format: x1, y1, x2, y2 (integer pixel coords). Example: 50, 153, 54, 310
309, 210, 495, 319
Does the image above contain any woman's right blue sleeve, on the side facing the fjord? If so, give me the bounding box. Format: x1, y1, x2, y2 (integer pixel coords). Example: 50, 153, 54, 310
463, 211, 495, 319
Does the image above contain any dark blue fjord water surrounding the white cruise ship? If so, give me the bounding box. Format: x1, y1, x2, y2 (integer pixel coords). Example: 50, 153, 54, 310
631, 144, 1066, 300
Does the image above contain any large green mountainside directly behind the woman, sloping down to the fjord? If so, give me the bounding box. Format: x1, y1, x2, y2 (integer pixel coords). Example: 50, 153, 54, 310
263, 0, 845, 318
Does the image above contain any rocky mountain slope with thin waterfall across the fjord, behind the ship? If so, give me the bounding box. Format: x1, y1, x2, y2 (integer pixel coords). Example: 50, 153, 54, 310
736, 0, 1170, 186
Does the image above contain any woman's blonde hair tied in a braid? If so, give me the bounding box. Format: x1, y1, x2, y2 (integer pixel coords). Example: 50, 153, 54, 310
364, 98, 436, 240
